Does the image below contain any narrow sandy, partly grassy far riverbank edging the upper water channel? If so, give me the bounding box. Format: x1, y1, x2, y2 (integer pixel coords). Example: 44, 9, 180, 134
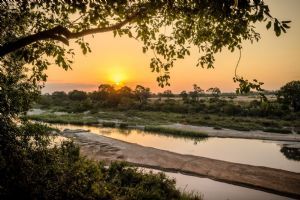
27, 110, 300, 142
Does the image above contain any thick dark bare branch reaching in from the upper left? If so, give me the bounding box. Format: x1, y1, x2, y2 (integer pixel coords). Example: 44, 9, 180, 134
0, 13, 138, 57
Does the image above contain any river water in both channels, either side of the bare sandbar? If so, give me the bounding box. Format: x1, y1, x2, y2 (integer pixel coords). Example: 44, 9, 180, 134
47, 124, 300, 200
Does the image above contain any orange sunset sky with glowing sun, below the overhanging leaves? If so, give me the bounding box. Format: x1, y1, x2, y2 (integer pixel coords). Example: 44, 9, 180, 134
43, 0, 300, 93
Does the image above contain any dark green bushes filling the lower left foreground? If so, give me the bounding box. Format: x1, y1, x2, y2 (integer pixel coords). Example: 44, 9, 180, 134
0, 119, 200, 200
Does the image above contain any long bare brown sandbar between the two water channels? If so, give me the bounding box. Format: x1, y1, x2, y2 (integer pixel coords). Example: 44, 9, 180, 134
63, 131, 300, 198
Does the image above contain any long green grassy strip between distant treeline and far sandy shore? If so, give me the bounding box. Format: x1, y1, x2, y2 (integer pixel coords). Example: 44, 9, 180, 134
27, 110, 300, 134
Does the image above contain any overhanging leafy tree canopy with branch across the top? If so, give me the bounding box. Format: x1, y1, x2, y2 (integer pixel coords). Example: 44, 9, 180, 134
0, 0, 289, 101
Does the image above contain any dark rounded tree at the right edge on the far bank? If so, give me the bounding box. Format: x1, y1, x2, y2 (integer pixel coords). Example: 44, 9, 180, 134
277, 81, 300, 112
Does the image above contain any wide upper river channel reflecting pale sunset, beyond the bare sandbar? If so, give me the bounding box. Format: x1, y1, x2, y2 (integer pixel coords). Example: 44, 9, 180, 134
47, 124, 300, 173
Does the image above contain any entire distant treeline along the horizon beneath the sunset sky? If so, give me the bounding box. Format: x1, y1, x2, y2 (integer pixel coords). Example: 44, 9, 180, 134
38, 81, 300, 117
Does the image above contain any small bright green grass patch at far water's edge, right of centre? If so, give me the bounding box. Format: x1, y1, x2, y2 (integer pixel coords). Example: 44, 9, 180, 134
144, 126, 208, 138
